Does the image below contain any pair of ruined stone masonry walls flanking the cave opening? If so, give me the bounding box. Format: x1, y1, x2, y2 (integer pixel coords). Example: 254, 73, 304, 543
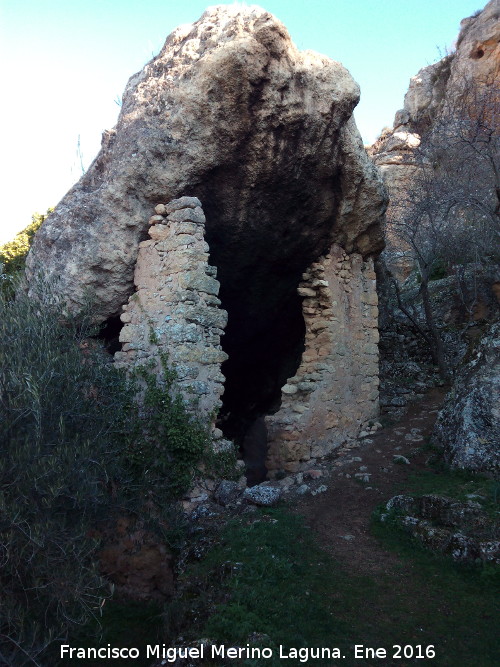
115, 197, 378, 479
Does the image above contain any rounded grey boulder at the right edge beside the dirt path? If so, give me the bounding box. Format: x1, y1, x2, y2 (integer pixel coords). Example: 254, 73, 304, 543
433, 324, 500, 472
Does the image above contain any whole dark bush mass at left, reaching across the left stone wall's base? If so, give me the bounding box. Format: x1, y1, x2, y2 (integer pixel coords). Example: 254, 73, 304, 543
0, 285, 213, 667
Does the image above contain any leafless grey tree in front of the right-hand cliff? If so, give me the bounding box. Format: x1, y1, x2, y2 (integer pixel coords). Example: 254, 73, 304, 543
388, 73, 500, 379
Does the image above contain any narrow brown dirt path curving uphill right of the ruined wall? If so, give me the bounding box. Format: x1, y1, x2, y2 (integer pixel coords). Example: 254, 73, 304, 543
296, 389, 445, 575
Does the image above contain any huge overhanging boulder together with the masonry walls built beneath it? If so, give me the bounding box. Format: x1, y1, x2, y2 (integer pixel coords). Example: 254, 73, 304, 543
27, 5, 385, 474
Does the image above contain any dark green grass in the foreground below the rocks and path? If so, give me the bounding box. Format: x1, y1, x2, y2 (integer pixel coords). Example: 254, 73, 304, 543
173, 507, 499, 667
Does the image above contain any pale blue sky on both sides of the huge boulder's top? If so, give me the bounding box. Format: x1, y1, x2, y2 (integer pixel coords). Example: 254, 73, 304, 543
0, 0, 485, 243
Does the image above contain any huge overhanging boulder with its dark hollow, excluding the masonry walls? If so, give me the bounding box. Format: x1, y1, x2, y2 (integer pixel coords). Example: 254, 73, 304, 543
27, 6, 385, 474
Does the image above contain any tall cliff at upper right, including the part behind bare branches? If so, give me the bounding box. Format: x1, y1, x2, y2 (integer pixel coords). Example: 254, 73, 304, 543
370, 0, 500, 276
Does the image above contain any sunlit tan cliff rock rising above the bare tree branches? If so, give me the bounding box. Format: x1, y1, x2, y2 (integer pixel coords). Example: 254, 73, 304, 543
369, 0, 500, 278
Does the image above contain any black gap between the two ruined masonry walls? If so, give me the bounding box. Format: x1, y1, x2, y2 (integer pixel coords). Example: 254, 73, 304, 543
198, 204, 318, 486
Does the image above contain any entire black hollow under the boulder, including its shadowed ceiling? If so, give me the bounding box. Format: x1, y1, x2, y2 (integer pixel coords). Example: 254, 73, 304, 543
193, 164, 340, 485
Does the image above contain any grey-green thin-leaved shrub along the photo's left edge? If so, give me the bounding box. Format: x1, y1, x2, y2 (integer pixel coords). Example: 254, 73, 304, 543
0, 280, 133, 665
